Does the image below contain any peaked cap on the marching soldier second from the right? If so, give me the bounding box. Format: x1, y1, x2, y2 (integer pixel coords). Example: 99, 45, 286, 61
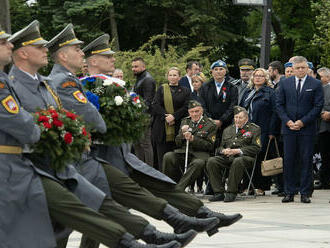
46, 23, 84, 53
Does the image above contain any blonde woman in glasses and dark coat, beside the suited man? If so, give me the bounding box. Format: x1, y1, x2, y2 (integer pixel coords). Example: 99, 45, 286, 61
240, 68, 278, 195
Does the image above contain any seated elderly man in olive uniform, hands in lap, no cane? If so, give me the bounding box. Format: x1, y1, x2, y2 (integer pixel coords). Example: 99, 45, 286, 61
206, 106, 261, 202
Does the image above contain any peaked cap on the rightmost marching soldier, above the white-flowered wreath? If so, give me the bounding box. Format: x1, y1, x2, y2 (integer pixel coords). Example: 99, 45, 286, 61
83, 34, 115, 58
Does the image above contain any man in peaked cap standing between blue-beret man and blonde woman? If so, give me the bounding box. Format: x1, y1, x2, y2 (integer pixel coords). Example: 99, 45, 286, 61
231, 58, 255, 104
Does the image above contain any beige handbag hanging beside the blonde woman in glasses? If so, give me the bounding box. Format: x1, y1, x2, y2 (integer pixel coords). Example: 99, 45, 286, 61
261, 138, 283, 176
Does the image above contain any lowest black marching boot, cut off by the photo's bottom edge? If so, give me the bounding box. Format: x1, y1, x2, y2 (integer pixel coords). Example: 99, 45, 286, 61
117, 233, 181, 248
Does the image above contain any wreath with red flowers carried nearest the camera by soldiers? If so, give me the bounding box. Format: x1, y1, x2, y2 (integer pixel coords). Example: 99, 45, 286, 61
32, 108, 91, 171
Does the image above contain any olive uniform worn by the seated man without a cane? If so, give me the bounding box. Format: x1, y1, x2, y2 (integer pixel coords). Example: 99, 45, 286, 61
206, 119, 261, 199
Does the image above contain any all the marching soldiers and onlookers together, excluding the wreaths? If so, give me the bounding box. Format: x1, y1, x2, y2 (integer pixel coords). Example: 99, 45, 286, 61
0, 18, 330, 248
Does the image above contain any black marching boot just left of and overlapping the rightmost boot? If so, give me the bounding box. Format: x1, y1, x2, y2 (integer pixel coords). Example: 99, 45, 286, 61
163, 204, 219, 233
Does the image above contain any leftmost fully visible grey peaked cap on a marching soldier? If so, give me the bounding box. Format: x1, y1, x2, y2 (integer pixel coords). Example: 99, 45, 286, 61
8, 20, 48, 50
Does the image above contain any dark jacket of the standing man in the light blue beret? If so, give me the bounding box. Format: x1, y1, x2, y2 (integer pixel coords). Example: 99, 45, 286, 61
200, 79, 238, 127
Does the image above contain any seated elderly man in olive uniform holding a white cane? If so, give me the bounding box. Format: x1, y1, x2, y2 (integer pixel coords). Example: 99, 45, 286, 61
163, 100, 217, 190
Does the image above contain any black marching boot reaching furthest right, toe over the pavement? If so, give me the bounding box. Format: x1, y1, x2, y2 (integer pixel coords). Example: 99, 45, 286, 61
196, 206, 243, 236
